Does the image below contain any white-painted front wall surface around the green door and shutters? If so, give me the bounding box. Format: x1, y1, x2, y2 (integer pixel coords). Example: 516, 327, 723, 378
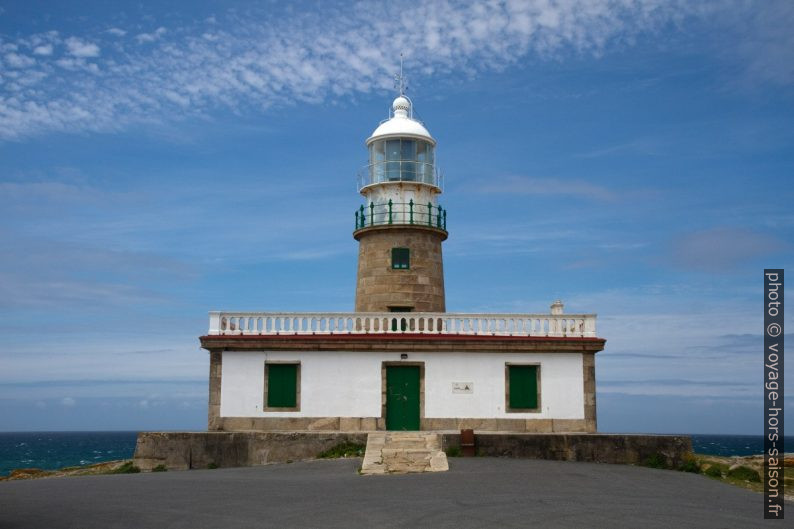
221, 351, 584, 419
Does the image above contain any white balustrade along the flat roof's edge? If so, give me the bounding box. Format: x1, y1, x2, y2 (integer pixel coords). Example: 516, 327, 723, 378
204, 312, 597, 338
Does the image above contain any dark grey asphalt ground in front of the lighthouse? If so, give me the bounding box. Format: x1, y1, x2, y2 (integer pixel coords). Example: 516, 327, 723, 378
0, 458, 780, 529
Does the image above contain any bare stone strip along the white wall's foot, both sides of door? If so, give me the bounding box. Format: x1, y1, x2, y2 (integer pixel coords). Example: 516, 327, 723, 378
207, 417, 596, 433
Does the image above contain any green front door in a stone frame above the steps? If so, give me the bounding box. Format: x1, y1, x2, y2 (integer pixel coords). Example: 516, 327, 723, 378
386, 366, 419, 430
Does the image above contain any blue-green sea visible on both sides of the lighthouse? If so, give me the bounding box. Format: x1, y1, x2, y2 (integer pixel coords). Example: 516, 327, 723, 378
0, 432, 794, 476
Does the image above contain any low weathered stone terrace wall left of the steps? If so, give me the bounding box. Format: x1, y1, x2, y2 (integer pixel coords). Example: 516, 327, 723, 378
134, 432, 367, 470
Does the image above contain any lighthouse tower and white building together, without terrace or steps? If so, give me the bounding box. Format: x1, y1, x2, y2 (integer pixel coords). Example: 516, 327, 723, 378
201, 91, 605, 432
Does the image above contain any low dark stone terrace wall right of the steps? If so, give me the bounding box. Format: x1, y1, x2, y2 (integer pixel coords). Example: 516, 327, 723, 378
443, 433, 692, 467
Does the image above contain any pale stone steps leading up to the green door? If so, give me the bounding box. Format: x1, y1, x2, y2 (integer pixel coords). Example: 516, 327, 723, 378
361, 432, 449, 475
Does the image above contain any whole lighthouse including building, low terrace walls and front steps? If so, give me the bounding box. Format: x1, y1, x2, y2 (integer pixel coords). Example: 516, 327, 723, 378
135, 76, 691, 473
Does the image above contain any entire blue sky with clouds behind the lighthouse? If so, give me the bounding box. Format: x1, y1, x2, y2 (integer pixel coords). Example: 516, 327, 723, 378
0, 0, 794, 433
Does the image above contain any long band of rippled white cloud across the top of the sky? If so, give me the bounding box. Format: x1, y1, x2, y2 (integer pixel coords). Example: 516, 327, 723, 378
0, 0, 732, 140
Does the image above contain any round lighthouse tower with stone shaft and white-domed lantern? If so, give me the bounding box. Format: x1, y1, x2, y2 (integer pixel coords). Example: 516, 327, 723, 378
353, 90, 447, 312
